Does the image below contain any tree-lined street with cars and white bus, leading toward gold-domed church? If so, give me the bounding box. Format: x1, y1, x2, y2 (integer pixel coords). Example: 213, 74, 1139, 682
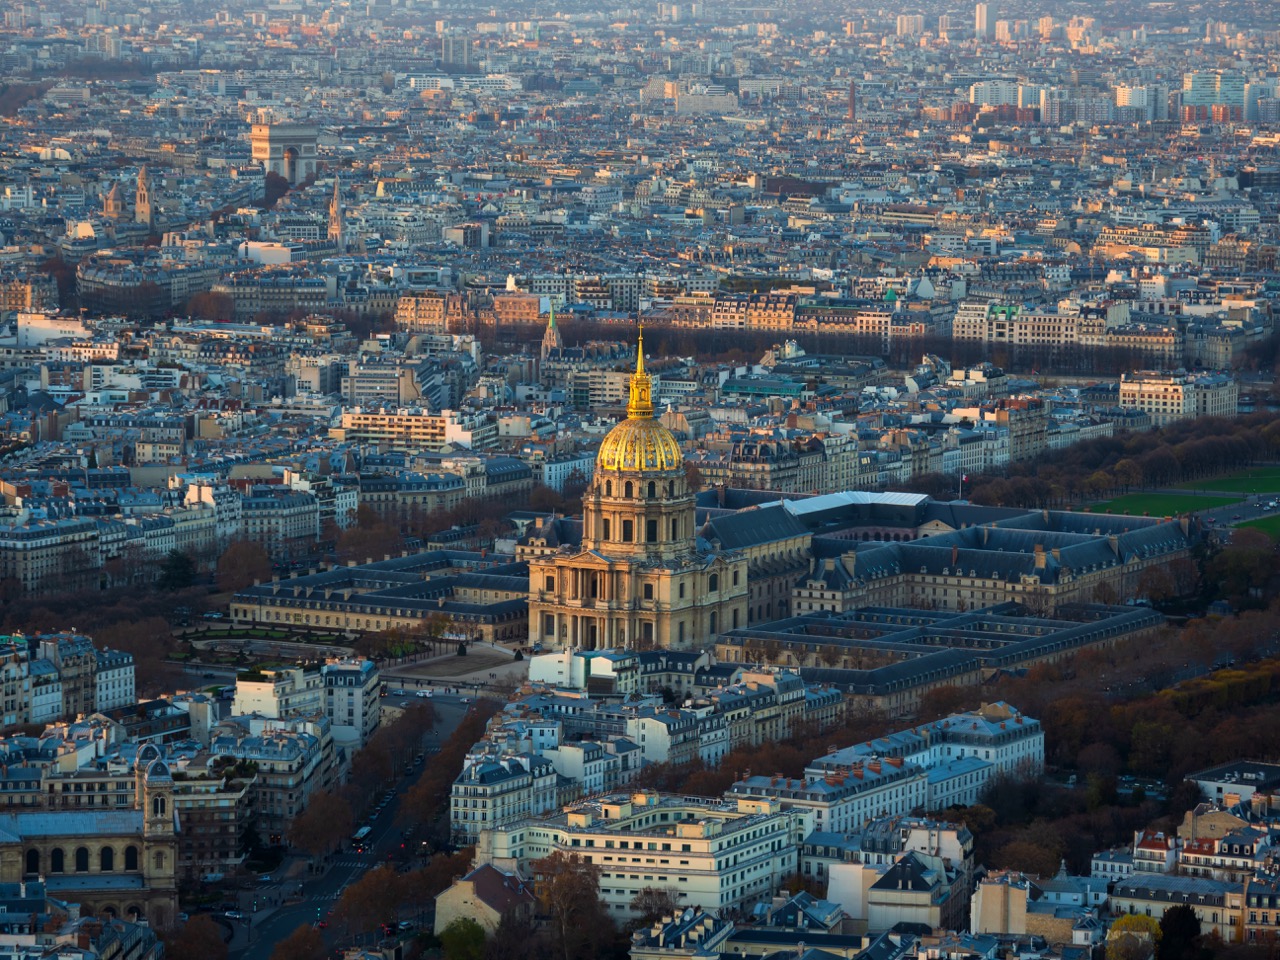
232, 694, 467, 960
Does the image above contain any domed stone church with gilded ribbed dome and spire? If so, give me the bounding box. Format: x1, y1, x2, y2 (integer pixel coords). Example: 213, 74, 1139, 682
529, 332, 748, 650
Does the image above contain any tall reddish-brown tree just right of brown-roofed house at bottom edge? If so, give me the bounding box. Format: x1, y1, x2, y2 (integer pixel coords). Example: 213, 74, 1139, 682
534, 850, 613, 960
